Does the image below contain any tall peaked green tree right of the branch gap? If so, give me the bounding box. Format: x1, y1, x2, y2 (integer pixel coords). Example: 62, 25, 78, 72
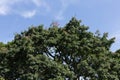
48, 17, 114, 80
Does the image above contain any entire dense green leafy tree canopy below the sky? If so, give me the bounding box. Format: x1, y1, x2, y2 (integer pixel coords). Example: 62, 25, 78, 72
0, 17, 120, 80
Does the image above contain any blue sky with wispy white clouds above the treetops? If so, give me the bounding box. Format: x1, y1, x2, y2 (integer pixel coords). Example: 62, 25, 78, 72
0, 0, 120, 51
